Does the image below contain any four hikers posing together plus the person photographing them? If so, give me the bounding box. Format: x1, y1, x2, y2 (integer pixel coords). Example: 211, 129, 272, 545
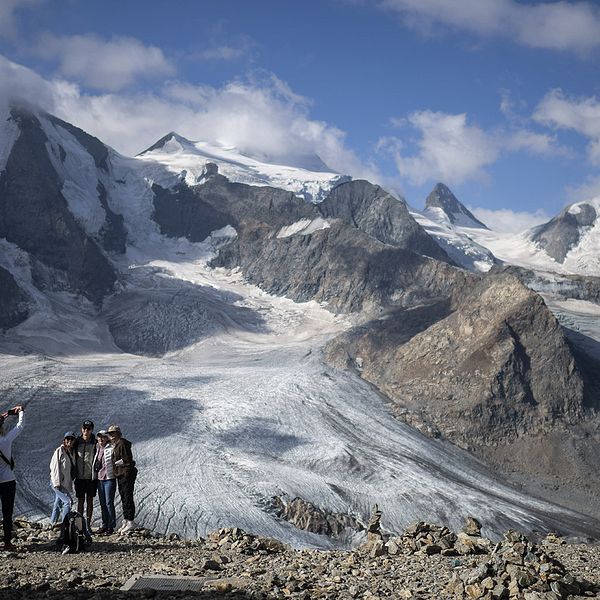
0, 405, 137, 550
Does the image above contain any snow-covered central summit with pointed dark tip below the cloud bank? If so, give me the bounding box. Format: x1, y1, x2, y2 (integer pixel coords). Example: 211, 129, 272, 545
138, 132, 350, 203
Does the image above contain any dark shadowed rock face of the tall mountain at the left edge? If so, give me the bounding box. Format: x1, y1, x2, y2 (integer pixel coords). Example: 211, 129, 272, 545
0, 111, 116, 302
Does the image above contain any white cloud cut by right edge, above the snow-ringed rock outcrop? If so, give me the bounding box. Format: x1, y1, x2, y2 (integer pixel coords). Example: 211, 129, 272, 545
534, 90, 600, 164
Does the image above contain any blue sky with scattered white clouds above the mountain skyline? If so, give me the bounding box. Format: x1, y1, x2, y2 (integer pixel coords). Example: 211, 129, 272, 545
0, 0, 600, 228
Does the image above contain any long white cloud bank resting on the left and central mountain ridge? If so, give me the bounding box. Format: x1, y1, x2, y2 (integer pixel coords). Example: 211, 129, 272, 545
0, 57, 383, 183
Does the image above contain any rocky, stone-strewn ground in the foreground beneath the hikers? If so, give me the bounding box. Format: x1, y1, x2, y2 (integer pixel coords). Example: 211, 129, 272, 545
0, 513, 600, 600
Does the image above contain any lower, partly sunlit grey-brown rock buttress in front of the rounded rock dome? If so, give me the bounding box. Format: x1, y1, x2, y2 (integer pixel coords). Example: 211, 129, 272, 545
213, 221, 470, 312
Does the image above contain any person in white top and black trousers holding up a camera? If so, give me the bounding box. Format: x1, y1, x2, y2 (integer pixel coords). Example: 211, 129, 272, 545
0, 405, 23, 550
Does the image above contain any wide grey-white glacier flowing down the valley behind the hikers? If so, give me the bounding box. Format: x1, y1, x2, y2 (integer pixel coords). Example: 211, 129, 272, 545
0, 236, 597, 548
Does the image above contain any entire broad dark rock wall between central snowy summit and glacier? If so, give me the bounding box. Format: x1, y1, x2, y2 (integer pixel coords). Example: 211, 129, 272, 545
154, 174, 462, 312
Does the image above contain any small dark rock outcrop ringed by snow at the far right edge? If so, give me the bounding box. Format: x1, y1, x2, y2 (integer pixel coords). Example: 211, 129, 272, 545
531, 204, 597, 263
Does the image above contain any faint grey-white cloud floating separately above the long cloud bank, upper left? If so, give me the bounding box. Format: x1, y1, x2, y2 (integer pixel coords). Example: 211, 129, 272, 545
34, 34, 175, 91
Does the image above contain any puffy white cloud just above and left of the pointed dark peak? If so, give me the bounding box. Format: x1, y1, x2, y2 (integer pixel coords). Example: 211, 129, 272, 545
387, 110, 500, 185
